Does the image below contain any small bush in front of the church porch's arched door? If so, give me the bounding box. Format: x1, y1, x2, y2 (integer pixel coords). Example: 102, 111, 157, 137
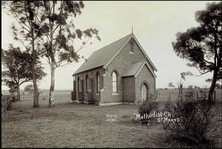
139, 95, 158, 124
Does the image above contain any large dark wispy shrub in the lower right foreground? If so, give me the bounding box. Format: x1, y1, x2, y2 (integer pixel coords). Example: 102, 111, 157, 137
164, 90, 213, 147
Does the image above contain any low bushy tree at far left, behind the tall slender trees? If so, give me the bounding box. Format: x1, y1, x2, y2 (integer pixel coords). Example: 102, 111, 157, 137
2, 45, 46, 100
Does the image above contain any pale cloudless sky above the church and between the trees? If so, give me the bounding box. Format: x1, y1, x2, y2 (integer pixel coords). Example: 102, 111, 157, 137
1, 1, 219, 90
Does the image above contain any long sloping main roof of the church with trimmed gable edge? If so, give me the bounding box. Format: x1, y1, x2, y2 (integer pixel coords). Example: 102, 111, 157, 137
73, 34, 157, 75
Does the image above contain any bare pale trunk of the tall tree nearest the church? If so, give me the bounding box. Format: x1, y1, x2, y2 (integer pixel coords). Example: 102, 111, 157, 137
49, 63, 55, 107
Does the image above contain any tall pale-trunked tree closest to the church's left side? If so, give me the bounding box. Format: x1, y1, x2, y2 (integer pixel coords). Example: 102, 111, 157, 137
39, 1, 100, 107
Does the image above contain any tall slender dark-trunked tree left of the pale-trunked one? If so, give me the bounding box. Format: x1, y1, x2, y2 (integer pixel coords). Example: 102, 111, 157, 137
2, 1, 48, 108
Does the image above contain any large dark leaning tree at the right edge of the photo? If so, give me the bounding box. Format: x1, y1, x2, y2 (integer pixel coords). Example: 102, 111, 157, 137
172, 2, 222, 100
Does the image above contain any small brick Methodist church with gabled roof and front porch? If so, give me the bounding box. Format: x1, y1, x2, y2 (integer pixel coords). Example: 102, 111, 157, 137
72, 33, 157, 105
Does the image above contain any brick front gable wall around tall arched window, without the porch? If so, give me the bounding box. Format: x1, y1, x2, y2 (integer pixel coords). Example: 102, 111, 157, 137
102, 38, 155, 103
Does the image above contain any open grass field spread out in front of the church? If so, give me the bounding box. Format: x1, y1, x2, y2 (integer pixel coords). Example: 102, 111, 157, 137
1, 91, 221, 148
